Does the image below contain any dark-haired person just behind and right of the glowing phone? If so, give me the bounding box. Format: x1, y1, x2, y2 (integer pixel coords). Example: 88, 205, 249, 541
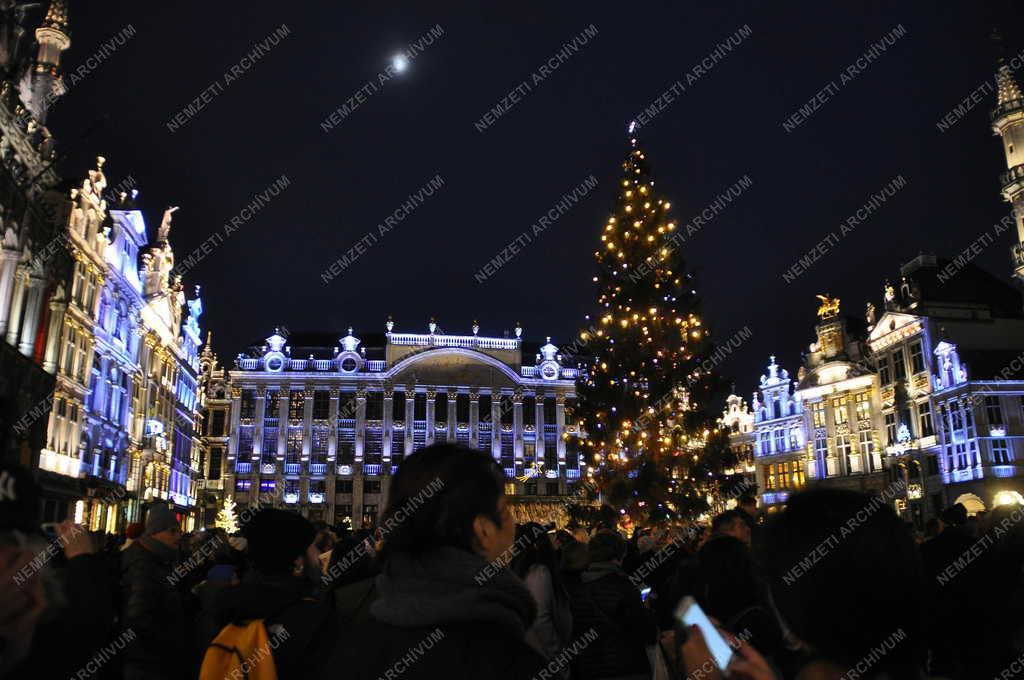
696, 536, 782, 660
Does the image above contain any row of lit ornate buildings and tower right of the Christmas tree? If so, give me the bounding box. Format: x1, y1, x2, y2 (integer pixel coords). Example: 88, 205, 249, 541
727, 57, 1024, 527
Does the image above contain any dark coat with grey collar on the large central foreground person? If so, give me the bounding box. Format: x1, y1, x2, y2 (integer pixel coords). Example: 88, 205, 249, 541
330, 548, 557, 680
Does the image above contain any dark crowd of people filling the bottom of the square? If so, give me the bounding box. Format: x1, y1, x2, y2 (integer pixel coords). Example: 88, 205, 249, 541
0, 444, 1024, 680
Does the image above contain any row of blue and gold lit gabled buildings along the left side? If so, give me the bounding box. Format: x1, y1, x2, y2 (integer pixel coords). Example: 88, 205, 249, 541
0, 0, 209, 532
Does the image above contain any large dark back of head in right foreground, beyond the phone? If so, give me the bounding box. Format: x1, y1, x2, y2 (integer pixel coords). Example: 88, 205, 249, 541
763, 488, 924, 677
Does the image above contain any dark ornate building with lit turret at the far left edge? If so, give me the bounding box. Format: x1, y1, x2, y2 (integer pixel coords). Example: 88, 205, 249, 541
0, 1, 71, 493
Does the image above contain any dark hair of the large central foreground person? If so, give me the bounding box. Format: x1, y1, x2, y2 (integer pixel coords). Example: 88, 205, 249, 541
381, 443, 513, 561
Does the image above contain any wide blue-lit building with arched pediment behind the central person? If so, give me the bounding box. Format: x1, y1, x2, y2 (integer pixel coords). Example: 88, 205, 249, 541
216, 320, 580, 526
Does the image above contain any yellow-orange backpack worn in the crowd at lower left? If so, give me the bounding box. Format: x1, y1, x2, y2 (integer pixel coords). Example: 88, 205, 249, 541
199, 619, 281, 680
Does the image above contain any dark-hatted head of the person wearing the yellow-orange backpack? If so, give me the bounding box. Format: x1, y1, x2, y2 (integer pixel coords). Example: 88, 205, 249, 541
242, 508, 316, 578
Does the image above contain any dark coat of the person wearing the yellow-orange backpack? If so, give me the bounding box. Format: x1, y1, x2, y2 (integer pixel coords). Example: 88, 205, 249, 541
207, 572, 338, 680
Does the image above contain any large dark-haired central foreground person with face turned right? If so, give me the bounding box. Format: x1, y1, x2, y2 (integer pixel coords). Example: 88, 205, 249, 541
330, 443, 547, 680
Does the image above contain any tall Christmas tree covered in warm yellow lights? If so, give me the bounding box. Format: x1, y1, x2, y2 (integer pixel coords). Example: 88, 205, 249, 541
580, 125, 734, 521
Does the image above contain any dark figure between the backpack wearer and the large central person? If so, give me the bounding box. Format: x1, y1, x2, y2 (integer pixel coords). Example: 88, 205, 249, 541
324, 535, 379, 627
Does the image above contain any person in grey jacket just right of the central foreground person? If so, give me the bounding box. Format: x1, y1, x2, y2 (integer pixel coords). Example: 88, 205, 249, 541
510, 522, 572, 678
